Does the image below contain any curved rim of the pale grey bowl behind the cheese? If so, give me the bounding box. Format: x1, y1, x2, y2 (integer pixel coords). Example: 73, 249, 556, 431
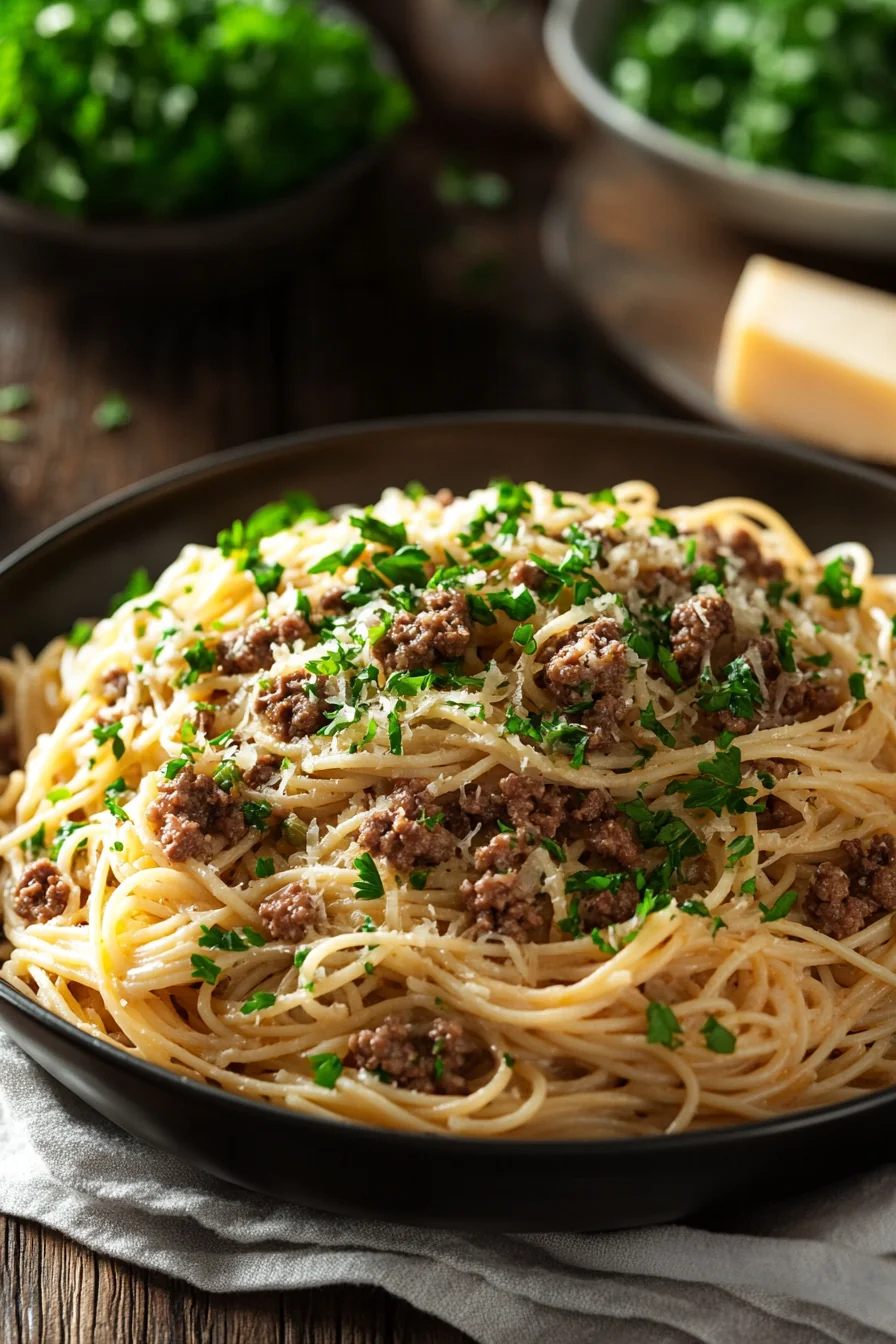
543, 0, 896, 218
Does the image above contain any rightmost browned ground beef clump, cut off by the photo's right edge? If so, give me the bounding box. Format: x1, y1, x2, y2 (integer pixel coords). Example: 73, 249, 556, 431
805, 831, 896, 938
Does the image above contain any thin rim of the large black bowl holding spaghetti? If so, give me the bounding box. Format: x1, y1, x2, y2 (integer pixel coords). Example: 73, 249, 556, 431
0, 411, 896, 1159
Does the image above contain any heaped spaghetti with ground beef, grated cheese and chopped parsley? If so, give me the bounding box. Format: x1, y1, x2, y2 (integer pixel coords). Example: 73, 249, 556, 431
0, 481, 896, 1138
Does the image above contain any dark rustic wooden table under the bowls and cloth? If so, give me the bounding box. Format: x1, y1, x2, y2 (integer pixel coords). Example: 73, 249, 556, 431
0, 110, 664, 1344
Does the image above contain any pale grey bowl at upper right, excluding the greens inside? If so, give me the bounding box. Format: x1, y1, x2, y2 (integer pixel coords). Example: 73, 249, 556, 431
544, 0, 896, 257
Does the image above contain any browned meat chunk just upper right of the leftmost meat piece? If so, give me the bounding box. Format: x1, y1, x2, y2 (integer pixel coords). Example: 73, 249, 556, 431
146, 765, 246, 863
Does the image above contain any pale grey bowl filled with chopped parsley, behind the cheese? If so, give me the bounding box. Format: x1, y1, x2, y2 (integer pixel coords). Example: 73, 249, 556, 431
545, 0, 896, 255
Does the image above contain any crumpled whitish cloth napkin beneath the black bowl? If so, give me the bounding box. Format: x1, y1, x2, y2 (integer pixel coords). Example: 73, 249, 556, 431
0, 1034, 896, 1344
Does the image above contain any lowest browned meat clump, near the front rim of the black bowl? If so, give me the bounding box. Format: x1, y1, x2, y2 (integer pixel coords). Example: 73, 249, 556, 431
345, 1013, 476, 1095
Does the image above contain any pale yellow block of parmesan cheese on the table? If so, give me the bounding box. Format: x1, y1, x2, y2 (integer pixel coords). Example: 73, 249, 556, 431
716, 257, 896, 464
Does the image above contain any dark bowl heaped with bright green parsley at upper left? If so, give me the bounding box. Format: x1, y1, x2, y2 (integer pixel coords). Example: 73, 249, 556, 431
0, 0, 412, 254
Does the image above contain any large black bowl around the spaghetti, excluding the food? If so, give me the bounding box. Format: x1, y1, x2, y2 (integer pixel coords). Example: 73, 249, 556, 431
0, 415, 896, 1231
